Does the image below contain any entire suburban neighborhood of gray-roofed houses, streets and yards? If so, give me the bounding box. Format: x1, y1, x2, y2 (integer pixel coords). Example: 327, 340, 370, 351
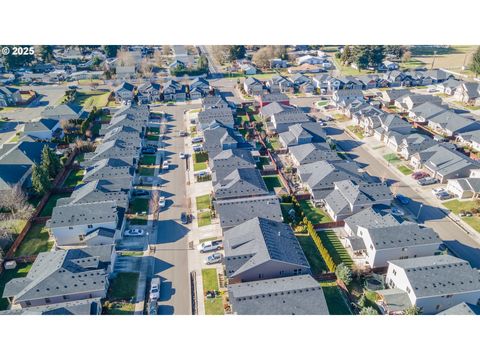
0, 45, 480, 315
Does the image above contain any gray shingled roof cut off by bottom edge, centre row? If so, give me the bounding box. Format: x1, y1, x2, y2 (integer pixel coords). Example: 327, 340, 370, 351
228, 275, 329, 315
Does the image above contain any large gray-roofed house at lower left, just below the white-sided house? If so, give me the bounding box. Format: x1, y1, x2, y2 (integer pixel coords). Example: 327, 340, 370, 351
3, 245, 115, 309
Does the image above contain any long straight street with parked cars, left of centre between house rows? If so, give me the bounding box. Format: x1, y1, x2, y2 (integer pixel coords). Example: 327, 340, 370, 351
151, 105, 198, 315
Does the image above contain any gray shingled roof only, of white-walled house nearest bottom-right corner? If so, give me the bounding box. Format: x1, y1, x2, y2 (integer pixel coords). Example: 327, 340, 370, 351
389, 255, 480, 298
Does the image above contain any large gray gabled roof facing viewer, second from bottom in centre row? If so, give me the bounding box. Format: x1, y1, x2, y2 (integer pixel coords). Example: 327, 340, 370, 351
224, 217, 310, 277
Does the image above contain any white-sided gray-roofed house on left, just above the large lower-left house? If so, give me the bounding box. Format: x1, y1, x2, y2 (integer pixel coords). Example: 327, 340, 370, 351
46, 200, 125, 248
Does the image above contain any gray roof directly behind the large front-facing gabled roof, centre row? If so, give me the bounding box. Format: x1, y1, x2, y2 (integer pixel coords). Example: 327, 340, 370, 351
214, 195, 283, 229
